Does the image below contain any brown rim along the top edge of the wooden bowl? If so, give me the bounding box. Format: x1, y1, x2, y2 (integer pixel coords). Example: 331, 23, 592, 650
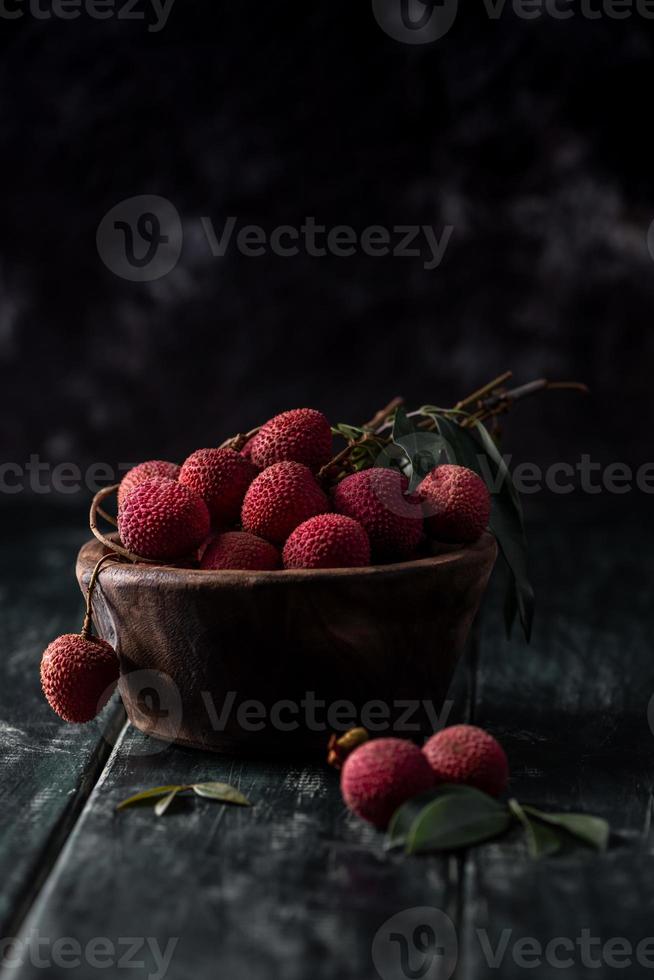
78, 531, 497, 588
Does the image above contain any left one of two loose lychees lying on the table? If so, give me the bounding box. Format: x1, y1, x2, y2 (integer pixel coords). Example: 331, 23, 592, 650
341, 738, 435, 830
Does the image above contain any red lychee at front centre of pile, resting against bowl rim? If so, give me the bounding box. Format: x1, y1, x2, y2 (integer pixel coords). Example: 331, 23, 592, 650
284, 514, 370, 568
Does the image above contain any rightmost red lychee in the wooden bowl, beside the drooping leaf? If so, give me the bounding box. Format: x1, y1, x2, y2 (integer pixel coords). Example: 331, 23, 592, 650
416, 463, 491, 542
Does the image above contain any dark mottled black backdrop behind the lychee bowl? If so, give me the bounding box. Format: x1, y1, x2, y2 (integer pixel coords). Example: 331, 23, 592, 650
0, 0, 654, 512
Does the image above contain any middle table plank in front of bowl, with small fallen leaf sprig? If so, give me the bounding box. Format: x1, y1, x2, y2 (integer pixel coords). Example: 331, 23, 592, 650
9, 729, 457, 980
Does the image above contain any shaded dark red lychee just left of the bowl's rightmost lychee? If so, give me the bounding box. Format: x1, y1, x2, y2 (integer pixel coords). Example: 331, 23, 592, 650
332, 467, 423, 561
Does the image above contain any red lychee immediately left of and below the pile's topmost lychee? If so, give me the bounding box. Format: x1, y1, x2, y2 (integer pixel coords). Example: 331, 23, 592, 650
179, 448, 259, 528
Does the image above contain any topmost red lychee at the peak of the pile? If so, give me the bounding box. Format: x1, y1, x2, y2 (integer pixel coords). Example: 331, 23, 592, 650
248, 408, 332, 472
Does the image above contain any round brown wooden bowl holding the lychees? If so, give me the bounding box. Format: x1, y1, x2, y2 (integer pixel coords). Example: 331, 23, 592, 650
77, 533, 497, 755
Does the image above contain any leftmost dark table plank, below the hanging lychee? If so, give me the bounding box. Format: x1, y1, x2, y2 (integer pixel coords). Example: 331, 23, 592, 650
0, 505, 122, 937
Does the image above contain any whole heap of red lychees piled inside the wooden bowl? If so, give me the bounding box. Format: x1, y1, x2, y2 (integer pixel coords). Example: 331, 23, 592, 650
118, 408, 490, 571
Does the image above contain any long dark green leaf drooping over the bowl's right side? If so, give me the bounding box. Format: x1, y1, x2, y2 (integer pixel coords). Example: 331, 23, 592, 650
438, 415, 534, 640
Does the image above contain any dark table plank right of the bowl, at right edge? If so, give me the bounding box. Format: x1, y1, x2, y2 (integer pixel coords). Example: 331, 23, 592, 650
460, 524, 654, 980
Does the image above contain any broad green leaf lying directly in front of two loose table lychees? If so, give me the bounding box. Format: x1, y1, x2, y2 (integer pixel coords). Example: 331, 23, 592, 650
406, 787, 511, 854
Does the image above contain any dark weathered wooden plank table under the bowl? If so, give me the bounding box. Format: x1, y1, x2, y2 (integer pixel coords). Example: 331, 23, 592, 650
0, 506, 654, 980
